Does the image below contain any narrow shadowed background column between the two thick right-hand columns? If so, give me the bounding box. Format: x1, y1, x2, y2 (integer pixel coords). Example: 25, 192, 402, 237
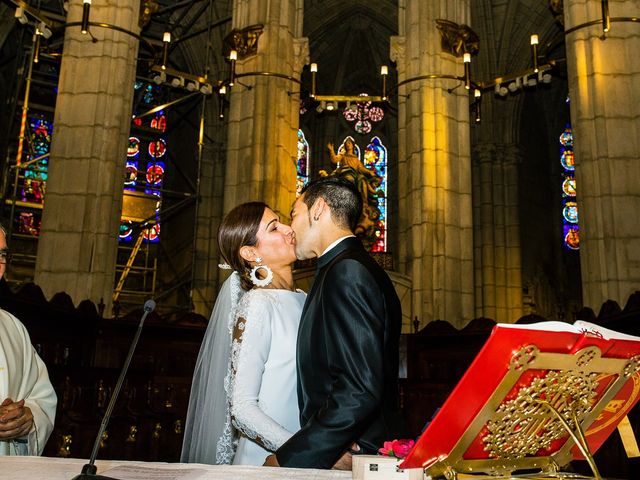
473, 144, 522, 322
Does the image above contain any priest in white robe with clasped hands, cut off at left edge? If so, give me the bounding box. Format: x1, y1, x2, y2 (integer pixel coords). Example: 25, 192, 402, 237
0, 225, 57, 456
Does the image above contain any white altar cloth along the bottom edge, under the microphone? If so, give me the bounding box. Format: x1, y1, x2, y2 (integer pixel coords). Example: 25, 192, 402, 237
0, 456, 351, 480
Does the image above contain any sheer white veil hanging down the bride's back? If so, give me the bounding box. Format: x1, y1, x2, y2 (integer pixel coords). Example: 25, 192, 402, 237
180, 272, 244, 464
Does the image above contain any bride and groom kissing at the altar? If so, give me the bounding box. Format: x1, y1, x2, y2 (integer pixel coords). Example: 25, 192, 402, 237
181, 177, 401, 469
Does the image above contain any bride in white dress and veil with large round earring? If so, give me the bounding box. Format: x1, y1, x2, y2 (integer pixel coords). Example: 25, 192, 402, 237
181, 202, 306, 465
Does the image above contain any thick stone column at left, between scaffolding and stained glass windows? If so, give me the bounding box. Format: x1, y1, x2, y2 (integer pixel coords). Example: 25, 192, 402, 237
35, 0, 140, 312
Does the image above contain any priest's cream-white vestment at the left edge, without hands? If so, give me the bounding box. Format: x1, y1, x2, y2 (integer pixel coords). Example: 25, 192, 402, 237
0, 309, 57, 455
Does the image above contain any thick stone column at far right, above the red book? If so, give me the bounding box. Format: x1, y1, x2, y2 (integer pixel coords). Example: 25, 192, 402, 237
564, 0, 640, 309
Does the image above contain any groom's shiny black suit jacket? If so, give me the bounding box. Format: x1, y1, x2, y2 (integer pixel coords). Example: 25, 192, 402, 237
276, 237, 402, 468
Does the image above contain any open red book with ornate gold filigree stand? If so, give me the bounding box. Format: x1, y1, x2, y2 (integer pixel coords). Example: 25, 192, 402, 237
400, 321, 640, 478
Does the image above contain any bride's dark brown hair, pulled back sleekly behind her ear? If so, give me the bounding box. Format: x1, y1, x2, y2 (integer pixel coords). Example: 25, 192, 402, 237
218, 202, 269, 290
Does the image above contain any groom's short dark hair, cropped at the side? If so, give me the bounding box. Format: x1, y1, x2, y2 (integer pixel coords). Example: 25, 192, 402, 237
302, 176, 362, 232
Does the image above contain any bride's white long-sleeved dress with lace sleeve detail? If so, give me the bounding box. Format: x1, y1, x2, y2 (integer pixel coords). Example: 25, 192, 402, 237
225, 289, 306, 465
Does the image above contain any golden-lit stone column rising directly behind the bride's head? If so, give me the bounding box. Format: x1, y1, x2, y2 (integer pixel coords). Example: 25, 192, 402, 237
224, 0, 309, 217
